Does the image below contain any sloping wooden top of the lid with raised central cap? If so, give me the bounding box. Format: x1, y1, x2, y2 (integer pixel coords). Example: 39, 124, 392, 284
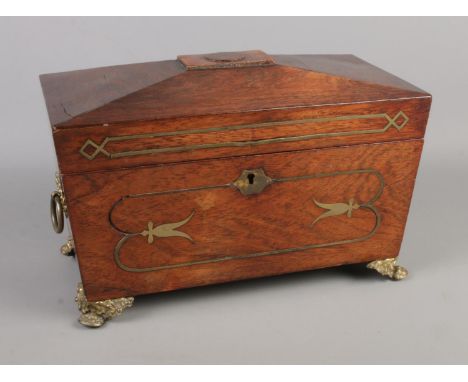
40, 51, 430, 129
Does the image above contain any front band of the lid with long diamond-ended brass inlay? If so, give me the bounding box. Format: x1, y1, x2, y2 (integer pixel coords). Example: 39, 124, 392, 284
54, 97, 431, 174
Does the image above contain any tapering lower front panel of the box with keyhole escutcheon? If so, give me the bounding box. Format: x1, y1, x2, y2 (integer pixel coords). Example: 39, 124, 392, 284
63, 140, 422, 300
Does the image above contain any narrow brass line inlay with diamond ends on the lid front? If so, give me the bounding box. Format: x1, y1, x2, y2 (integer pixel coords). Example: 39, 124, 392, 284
80, 111, 409, 160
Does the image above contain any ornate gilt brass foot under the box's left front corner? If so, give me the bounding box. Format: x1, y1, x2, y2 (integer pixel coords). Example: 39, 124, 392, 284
75, 283, 133, 328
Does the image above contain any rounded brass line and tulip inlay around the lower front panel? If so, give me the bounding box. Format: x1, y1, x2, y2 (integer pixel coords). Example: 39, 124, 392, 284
109, 169, 385, 272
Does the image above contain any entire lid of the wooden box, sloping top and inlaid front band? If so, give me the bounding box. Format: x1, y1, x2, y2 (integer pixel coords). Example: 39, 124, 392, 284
41, 51, 430, 172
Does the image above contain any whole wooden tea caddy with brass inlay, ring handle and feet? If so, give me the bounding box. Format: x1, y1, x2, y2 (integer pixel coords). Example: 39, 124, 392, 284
40, 51, 431, 327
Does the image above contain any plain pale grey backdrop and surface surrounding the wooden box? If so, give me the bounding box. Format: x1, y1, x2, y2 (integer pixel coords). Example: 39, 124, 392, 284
0, 18, 468, 364
